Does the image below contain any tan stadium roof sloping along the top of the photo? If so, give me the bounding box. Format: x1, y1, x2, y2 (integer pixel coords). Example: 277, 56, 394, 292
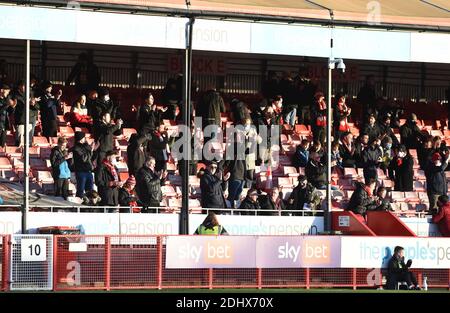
71, 0, 450, 28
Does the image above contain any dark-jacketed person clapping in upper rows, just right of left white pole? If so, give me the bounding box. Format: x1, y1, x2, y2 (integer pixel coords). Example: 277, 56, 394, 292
39, 81, 62, 138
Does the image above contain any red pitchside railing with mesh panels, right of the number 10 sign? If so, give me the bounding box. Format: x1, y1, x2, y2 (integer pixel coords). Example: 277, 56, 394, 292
46, 236, 450, 290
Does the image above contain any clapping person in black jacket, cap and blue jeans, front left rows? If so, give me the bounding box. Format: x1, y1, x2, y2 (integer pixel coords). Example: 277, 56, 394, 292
72, 131, 98, 198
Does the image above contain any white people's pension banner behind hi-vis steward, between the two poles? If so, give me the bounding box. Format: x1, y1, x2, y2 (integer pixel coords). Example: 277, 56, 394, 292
189, 214, 323, 236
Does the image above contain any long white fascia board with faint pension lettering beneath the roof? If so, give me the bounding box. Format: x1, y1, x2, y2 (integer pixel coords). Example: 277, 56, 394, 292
0, 6, 450, 63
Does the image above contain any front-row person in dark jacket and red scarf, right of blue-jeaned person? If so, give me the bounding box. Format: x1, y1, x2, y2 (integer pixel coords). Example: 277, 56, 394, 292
95, 151, 123, 213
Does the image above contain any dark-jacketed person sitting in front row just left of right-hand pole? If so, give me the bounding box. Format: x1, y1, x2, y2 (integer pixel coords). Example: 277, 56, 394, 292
287, 175, 321, 215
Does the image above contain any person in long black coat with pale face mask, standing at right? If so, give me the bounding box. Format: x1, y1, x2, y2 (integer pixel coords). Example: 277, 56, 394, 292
391, 145, 414, 191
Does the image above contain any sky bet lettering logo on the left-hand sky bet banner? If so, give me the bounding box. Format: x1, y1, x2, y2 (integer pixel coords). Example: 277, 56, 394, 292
178, 240, 233, 264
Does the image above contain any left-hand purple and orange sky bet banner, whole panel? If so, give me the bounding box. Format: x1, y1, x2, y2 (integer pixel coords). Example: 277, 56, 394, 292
166, 236, 256, 268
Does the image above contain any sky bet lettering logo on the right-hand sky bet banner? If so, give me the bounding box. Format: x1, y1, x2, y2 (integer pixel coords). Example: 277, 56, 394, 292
278, 239, 331, 265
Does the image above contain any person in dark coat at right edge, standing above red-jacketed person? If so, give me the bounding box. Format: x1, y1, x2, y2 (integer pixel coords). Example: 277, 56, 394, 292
425, 150, 450, 210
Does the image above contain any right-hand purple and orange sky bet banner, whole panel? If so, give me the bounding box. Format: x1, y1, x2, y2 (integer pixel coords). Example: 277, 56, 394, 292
256, 236, 340, 268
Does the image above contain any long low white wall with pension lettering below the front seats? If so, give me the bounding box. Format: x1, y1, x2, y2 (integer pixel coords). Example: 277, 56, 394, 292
0, 212, 440, 237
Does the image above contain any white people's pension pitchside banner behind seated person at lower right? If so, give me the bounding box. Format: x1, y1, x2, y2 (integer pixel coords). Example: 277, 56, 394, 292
341, 236, 450, 268
